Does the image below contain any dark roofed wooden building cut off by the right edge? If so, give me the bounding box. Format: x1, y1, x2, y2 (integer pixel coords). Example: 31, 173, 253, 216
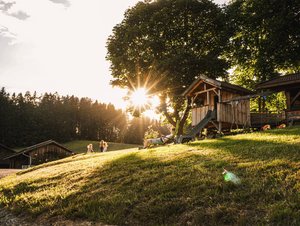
256, 73, 300, 122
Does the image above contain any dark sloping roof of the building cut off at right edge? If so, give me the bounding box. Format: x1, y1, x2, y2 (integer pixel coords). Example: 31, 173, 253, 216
256, 73, 300, 89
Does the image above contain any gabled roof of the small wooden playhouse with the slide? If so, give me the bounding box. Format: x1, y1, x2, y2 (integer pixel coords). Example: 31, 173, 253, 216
182, 75, 254, 96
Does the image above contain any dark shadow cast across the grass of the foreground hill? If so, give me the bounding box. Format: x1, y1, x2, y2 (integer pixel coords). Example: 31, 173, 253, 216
2, 133, 300, 225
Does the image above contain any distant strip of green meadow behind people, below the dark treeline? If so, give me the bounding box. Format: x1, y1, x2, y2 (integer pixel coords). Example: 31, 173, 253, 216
63, 140, 138, 153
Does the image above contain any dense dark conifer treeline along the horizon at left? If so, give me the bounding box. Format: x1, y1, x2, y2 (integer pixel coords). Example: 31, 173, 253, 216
0, 88, 157, 147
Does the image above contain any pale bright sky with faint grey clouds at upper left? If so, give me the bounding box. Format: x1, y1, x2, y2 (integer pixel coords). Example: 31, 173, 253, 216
0, 0, 226, 108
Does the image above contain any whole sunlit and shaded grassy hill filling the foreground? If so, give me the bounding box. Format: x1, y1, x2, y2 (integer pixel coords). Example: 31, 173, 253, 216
0, 127, 300, 225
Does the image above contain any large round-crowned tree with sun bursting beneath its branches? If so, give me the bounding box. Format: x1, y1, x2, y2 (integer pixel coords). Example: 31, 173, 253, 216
107, 0, 228, 134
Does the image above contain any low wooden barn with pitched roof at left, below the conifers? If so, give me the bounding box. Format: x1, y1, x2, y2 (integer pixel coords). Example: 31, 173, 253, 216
4, 140, 73, 169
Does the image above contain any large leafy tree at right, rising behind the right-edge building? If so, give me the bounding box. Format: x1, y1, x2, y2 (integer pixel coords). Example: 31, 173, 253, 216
227, 0, 300, 87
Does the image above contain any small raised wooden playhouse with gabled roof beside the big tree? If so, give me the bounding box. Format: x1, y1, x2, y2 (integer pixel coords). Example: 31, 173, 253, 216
183, 75, 253, 132
